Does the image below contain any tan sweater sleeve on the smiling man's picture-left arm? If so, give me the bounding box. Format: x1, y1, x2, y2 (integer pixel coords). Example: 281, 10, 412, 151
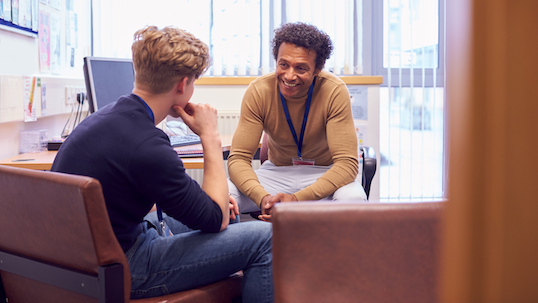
228, 85, 269, 206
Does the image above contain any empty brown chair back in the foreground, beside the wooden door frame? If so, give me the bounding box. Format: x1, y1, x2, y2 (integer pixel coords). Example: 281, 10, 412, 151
272, 202, 445, 303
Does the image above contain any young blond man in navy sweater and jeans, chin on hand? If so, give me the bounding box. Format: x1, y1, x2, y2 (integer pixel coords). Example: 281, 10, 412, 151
52, 26, 273, 302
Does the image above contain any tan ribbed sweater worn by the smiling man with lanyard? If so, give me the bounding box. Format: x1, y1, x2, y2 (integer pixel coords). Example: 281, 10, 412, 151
228, 71, 358, 205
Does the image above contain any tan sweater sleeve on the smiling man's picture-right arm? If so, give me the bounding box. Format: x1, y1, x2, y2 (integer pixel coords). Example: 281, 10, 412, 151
295, 84, 359, 201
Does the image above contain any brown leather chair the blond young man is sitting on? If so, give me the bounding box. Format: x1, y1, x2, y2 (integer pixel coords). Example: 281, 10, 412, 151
0, 165, 242, 303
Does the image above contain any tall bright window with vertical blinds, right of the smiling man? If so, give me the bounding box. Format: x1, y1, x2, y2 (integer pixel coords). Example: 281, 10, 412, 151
372, 0, 445, 200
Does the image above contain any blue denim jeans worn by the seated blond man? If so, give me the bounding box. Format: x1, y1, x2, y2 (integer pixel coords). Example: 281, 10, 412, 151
126, 212, 273, 302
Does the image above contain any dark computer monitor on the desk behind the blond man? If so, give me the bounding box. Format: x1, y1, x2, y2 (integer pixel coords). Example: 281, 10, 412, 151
84, 57, 134, 113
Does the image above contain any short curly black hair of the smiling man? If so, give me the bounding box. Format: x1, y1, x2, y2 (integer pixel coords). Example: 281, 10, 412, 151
273, 22, 333, 69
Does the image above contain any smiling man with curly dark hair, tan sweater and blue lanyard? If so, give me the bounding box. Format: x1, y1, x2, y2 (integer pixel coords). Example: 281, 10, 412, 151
228, 23, 366, 221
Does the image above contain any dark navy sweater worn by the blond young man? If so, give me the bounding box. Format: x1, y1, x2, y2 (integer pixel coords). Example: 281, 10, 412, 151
51, 94, 222, 251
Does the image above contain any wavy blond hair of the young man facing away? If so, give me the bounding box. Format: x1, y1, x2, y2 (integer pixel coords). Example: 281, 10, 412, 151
131, 26, 211, 94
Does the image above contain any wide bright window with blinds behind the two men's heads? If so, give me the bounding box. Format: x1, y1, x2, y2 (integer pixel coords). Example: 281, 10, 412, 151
92, 0, 362, 76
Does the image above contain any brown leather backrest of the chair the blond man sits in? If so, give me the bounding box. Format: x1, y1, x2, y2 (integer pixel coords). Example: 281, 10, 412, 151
0, 165, 131, 303
